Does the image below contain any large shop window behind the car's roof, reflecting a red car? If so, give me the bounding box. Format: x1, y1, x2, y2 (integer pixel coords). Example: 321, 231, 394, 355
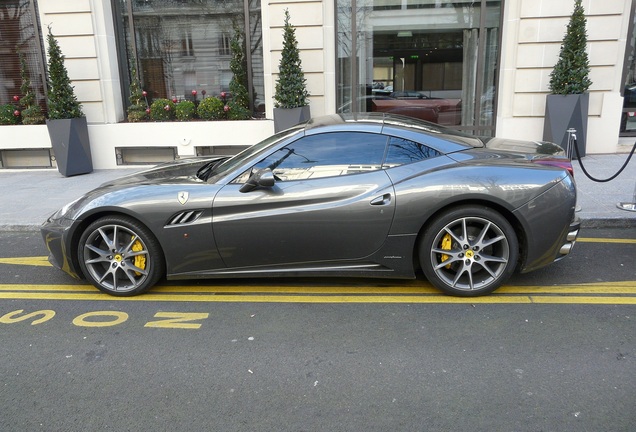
335, 0, 501, 135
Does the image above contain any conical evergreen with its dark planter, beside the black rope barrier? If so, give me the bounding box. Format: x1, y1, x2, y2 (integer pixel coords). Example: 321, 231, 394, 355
543, 0, 592, 156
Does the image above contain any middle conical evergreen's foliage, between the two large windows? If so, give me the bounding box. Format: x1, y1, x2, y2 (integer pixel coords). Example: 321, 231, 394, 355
274, 9, 309, 108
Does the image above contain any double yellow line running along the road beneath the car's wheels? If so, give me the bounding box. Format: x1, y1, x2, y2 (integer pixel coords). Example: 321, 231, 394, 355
0, 281, 636, 305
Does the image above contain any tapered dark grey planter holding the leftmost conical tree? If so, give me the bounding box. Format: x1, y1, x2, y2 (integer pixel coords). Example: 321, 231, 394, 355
46, 117, 93, 177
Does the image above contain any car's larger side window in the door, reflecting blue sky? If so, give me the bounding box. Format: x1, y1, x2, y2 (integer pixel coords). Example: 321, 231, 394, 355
248, 132, 387, 181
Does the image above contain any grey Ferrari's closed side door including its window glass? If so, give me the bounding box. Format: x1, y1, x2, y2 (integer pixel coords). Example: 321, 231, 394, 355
213, 132, 395, 268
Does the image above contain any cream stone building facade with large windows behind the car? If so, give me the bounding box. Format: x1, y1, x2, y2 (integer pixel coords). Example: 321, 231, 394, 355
0, 0, 636, 169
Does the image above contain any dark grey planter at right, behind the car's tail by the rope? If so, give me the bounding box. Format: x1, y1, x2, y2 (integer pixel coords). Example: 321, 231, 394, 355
543, 93, 590, 158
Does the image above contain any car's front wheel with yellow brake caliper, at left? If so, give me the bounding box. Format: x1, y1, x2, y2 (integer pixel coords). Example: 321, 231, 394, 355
77, 216, 165, 297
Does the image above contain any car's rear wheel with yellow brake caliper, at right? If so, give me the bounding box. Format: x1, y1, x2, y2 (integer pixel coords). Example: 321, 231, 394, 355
419, 205, 519, 297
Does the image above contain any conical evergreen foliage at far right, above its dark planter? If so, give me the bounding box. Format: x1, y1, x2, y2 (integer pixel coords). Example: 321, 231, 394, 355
550, 0, 592, 95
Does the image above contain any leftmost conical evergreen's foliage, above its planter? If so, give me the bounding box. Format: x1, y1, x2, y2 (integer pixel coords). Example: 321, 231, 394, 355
46, 27, 84, 120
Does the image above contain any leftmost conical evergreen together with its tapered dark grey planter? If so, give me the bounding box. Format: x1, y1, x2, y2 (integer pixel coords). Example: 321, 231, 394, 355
46, 27, 93, 177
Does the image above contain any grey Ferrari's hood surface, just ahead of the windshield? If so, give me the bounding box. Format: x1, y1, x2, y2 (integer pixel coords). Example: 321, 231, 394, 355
100, 156, 226, 188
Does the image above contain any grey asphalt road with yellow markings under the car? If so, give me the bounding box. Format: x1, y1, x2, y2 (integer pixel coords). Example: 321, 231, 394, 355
0, 230, 636, 432
